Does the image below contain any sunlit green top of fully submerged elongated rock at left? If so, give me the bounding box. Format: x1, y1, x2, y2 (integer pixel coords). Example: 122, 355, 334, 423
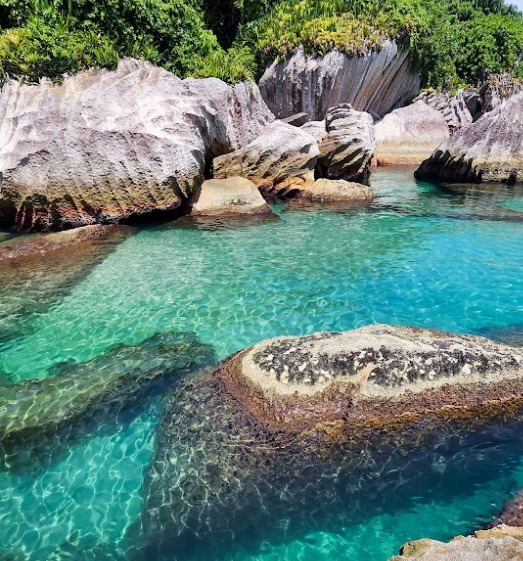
0, 333, 215, 452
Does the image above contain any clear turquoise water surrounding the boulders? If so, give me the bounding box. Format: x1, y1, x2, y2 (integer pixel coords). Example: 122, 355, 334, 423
0, 171, 523, 561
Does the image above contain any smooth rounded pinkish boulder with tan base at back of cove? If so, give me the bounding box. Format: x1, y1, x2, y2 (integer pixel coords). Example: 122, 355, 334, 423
375, 101, 450, 165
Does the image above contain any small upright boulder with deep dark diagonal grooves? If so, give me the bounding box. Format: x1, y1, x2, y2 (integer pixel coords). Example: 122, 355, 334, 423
318, 104, 376, 181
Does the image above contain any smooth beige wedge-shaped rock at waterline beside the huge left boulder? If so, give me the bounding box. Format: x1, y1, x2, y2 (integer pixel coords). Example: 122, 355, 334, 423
191, 177, 272, 216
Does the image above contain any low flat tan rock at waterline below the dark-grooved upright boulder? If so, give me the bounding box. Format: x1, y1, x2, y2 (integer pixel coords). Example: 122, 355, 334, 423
291, 179, 374, 206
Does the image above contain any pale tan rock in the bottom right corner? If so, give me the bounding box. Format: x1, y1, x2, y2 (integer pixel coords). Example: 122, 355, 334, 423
389, 526, 523, 561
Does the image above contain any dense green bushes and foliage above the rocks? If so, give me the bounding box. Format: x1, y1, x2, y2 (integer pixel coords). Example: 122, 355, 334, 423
0, 0, 523, 88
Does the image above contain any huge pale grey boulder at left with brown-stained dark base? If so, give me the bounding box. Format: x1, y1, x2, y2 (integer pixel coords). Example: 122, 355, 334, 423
0, 59, 274, 229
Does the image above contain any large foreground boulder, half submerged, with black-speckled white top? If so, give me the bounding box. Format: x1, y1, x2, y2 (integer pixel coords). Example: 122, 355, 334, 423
142, 326, 523, 559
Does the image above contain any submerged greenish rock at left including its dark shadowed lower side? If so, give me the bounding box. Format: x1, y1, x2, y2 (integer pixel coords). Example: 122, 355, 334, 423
0, 332, 216, 470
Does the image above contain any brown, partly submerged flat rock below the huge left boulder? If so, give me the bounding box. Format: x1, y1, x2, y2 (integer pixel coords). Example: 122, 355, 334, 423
0, 225, 130, 339
